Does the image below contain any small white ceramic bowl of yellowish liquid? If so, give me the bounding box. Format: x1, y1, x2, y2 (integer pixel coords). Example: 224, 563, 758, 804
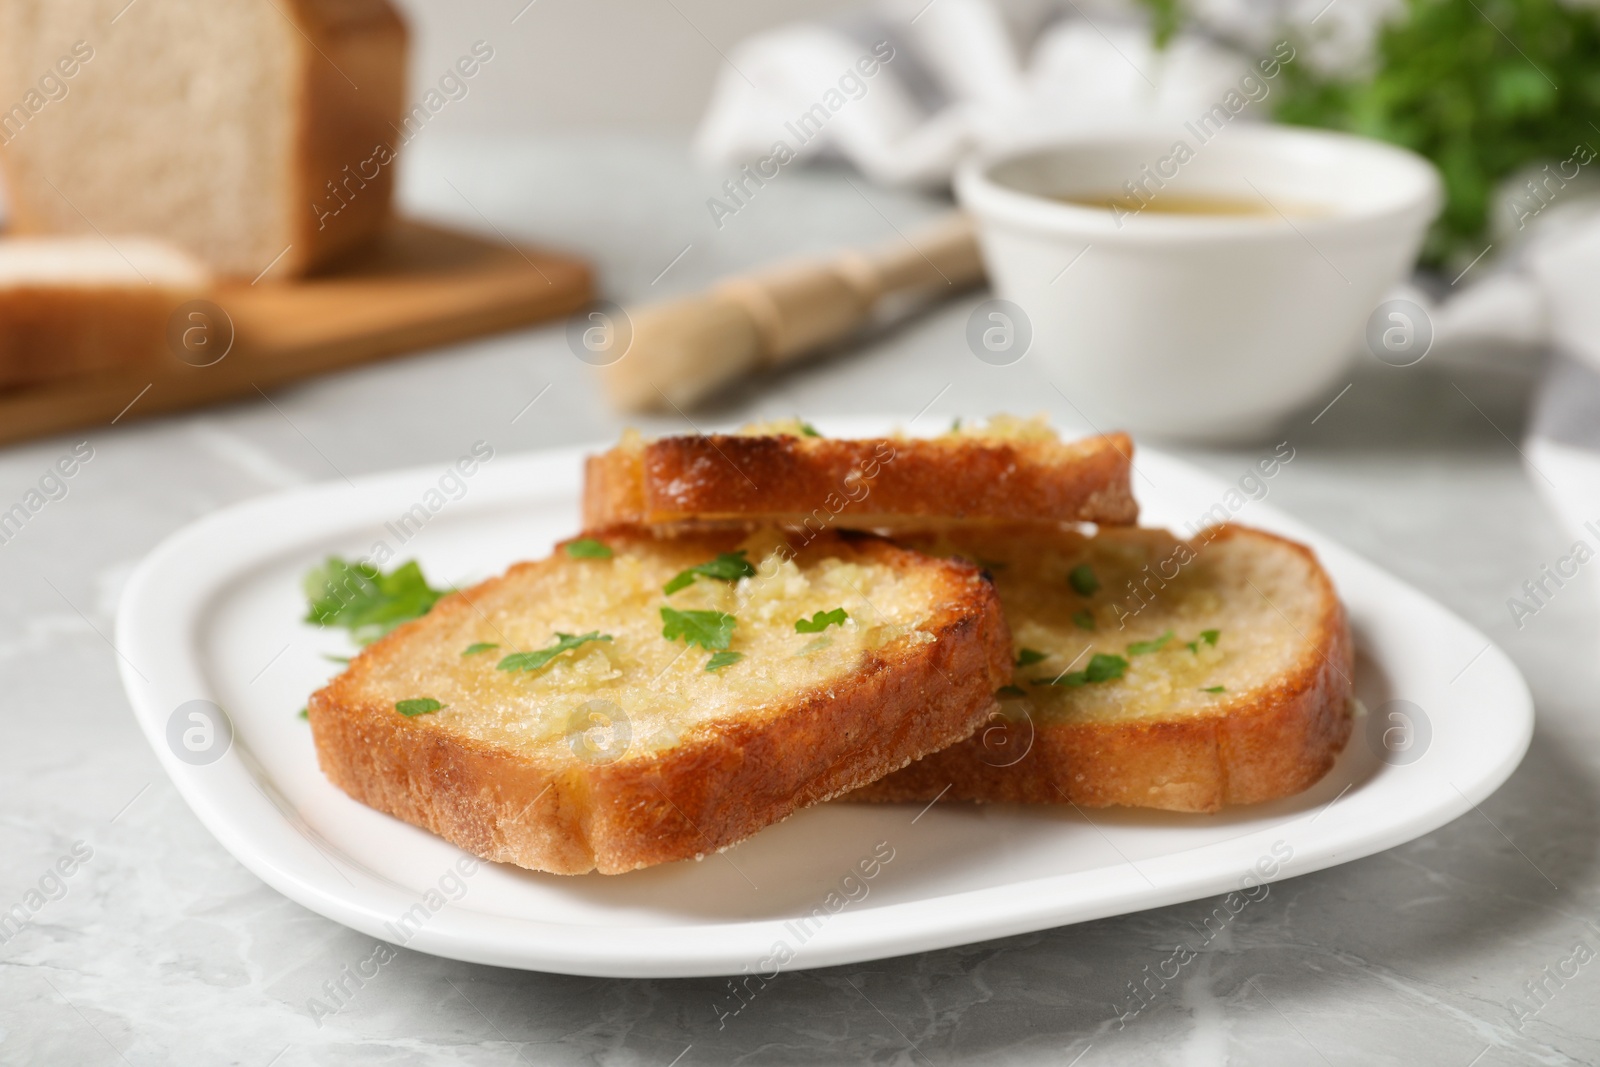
957, 125, 1442, 440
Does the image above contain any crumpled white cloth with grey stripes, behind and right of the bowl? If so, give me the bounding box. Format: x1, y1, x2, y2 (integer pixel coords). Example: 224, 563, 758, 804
694, 0, 1600, 552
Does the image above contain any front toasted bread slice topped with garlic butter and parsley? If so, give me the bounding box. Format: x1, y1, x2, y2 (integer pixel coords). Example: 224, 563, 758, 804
307, 530, 1011, 873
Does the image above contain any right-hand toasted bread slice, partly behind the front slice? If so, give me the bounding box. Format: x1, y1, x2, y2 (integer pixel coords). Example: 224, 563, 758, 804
851, 526, 1352, 811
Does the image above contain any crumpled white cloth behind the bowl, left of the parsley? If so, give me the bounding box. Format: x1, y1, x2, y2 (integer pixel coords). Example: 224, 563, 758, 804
694, 0, 1397, 186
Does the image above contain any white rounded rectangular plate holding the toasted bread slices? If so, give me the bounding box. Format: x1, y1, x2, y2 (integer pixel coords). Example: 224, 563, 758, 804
117, 419, 1533, 977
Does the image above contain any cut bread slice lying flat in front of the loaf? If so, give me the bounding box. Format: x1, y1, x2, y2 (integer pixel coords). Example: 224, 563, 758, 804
0, 235, 210, 389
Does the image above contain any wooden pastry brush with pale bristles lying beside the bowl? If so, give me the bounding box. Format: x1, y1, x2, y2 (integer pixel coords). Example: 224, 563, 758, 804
603, 214, 984, 411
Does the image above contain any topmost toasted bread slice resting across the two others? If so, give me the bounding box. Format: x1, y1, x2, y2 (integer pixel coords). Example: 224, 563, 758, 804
584, 418, 1139, 533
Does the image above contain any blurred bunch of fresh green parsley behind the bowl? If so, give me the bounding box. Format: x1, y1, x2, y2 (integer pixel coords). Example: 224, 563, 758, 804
1277, 0, 1600, 266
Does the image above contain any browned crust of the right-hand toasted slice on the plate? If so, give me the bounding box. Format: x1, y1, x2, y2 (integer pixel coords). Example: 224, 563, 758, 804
850, 526, 1354, 811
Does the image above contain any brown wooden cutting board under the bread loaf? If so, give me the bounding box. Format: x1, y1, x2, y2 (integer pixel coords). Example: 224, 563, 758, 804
0, 221, 594, 443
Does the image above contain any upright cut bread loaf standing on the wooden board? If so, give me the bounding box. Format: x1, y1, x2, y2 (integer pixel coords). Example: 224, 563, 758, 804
0, 0, 406, 280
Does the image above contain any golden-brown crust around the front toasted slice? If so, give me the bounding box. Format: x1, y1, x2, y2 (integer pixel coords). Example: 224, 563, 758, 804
307, 531, 1011, 875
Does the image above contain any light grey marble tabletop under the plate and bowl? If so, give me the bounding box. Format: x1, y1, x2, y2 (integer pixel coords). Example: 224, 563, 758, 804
0, 139, 1600, 1067
